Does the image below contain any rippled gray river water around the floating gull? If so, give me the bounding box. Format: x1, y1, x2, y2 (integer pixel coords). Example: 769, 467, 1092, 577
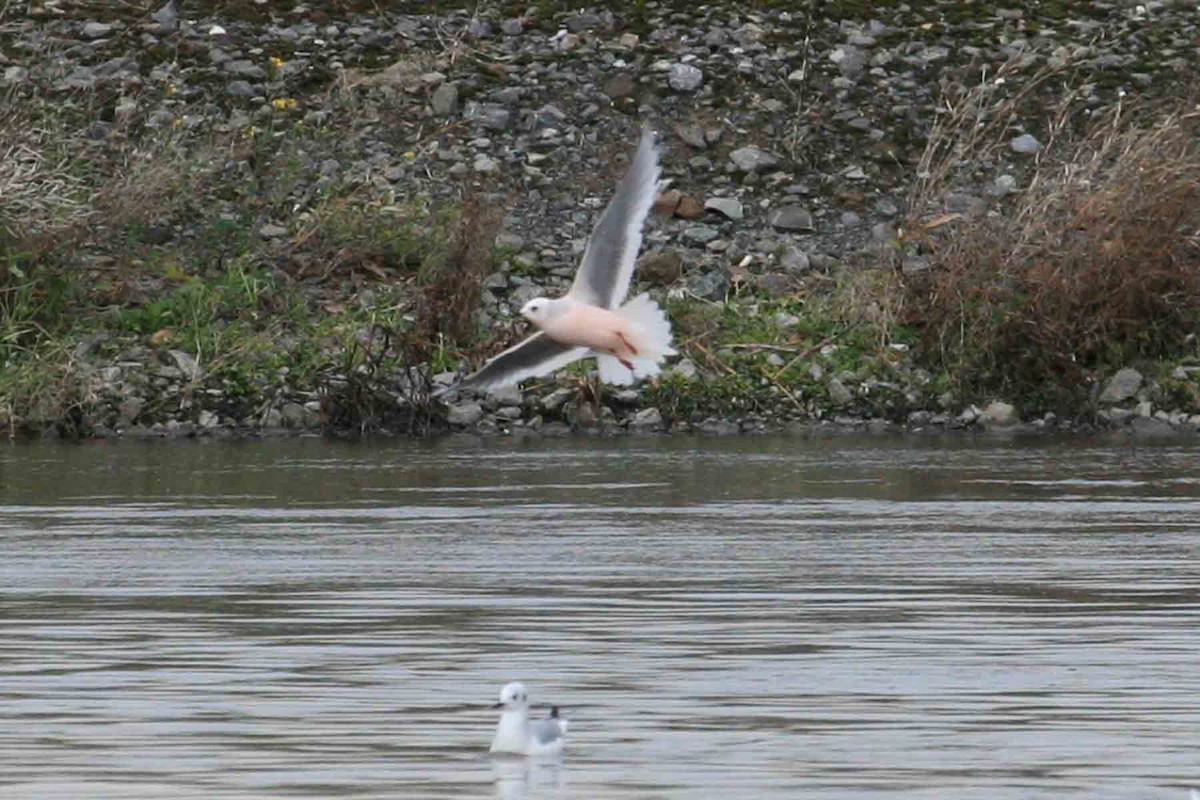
0, 438, 1200, 800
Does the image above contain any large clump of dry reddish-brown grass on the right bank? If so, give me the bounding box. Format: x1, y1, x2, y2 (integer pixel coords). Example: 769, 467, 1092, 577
905, 95, 1200, 404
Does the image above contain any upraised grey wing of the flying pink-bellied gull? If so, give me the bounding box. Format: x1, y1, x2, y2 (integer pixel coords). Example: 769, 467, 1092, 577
568, 127, 659, 308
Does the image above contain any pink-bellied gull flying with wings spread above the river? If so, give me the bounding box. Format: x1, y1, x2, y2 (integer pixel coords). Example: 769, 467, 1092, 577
460, 128, 676, 390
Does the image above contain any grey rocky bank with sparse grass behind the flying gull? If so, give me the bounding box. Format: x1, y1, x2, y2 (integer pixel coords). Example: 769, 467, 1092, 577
0, 0, 1200, 435
